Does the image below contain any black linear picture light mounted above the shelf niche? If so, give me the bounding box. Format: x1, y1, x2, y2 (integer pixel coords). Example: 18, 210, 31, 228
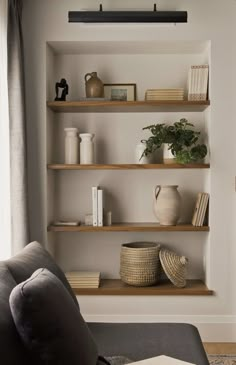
68, 4, 188, 23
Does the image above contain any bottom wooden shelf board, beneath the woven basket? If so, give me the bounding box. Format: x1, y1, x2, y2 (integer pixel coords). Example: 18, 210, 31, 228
73, 279, 214, 295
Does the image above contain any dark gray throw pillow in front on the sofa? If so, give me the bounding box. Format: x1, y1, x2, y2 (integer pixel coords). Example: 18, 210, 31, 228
10, 269, 98, 365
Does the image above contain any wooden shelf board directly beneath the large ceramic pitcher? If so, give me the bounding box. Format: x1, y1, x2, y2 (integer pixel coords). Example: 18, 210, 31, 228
48, 223, 210, 232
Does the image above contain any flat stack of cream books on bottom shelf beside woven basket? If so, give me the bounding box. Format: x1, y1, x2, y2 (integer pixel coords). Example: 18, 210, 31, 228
65, 271, 101, 289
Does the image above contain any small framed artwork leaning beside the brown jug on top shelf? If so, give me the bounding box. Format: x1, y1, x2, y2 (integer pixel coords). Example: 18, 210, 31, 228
104, 84, 136, 101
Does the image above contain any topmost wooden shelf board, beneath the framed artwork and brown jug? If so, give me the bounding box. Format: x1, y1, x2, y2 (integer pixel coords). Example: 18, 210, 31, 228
47, 100, 210, 113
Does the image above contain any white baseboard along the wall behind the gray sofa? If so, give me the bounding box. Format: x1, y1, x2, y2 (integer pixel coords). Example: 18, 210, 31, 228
83, 314, 236, 342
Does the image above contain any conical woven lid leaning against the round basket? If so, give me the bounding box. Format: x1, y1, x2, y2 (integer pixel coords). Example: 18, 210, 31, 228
160, 249, 188, 288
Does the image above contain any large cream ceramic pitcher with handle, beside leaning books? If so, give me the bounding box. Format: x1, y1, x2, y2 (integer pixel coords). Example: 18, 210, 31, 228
153, 185, 181, 226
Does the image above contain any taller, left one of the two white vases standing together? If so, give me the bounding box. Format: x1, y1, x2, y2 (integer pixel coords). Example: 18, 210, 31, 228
64, 128, 79, 165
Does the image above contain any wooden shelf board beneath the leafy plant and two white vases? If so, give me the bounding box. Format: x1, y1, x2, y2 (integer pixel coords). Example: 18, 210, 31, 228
47, 163, 210, 170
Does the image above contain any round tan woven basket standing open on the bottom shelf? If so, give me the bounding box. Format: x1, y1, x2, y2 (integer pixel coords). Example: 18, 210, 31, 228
120, 242, 161, 286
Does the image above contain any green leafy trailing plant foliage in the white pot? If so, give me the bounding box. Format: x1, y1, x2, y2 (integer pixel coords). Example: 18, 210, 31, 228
142, 119, 207, 164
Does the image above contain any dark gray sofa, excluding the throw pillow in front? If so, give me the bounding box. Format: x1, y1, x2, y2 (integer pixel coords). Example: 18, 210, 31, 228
0, 242, 209, 365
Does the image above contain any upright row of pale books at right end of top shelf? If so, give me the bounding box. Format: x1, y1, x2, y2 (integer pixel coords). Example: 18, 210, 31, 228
188, 65, 209, 101
